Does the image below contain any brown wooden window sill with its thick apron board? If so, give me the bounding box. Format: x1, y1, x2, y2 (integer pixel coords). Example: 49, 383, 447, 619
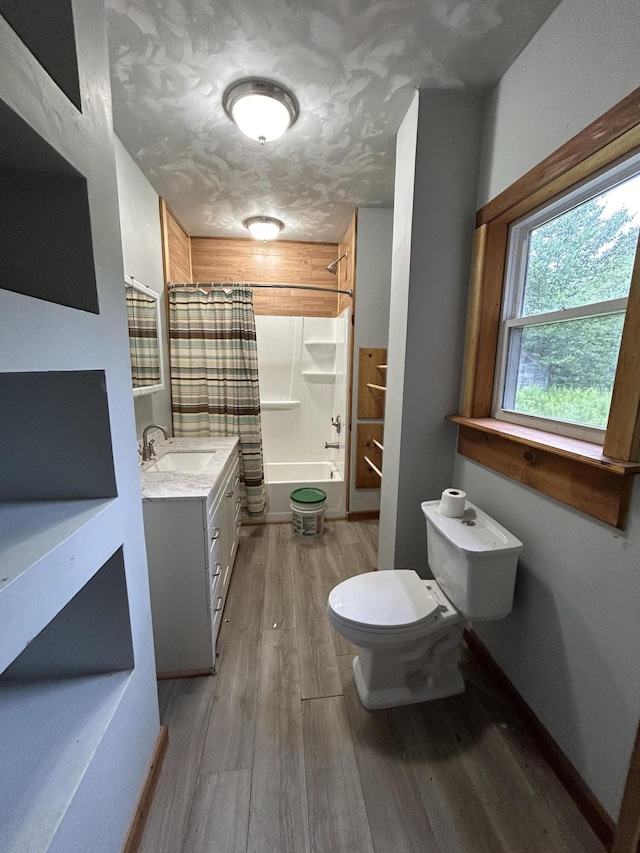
448, 415, 640, 530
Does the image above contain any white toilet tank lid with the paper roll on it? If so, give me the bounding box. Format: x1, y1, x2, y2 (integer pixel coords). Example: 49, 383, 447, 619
421, 500, 523, 556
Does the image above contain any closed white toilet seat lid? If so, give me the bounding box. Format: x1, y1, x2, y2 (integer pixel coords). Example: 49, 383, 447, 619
329, 569, 441, 634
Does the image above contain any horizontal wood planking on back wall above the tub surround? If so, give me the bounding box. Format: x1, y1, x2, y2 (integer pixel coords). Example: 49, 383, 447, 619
191, 237, 338, 317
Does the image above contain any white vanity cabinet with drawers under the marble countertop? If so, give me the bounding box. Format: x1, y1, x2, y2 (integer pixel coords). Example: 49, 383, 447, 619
143, 448, 241, 677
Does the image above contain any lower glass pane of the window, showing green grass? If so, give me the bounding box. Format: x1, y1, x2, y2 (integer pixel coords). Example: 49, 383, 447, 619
503, 313, 624, 429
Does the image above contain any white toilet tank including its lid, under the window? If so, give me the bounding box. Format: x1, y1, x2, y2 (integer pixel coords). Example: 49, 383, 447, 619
421, 500, 522, 620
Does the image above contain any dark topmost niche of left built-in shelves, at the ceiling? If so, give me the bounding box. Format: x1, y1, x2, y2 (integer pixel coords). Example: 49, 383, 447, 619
0, 0, 82, 110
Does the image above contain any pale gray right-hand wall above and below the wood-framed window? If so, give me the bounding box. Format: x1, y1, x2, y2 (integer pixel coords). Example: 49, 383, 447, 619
454, 0, 640, 818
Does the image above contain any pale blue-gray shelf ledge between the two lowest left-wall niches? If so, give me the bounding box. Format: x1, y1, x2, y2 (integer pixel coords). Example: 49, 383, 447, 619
0, 500, 117, 672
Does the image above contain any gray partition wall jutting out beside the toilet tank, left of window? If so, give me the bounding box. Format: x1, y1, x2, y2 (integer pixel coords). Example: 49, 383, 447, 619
378, 90, 483, 575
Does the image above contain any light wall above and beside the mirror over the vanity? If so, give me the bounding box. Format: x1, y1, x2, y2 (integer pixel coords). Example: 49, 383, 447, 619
115, 138, 171, 439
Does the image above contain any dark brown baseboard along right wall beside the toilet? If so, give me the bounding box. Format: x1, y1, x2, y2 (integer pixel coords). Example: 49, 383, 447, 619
464, 628, 615, 850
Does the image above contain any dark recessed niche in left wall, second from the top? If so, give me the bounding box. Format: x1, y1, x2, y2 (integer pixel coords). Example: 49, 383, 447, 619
0, 101, 99, 314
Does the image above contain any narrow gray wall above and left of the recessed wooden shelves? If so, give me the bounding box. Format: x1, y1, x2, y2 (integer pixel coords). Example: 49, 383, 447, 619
349, 207, 393, 512
